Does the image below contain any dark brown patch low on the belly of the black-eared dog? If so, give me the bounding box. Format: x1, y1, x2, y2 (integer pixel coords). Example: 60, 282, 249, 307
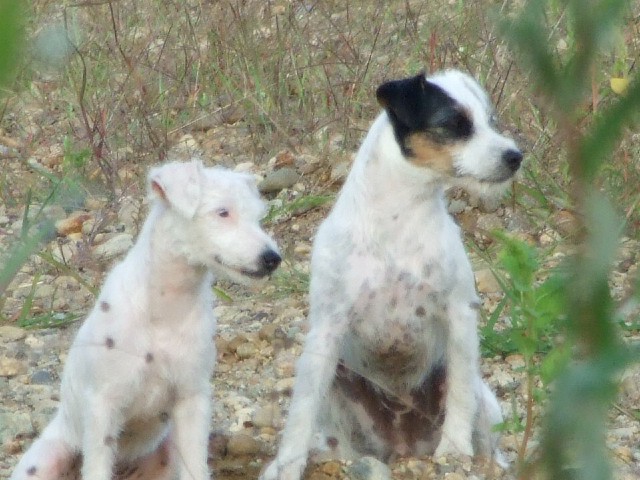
334, 364, 446, 455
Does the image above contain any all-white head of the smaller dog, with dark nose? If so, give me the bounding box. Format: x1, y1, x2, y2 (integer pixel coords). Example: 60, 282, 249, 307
149, 160, 281, 283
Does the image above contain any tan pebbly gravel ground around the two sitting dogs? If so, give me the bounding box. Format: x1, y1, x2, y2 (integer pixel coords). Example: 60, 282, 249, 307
0, 126, 640, 480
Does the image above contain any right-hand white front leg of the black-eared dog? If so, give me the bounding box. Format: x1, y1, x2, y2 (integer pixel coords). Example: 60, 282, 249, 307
435, 301, 479, 456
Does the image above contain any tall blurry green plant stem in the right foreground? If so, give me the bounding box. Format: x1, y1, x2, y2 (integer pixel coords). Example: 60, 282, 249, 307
504, 0, 640, 480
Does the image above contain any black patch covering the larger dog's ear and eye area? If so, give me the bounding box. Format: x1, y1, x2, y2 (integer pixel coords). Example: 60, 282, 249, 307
376, 73, 473, 157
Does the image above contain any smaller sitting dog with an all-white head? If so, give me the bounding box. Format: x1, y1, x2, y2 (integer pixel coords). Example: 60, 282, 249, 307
11, 161, 280, 480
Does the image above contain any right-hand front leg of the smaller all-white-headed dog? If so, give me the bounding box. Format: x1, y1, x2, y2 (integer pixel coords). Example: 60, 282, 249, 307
172, 388, 211, 480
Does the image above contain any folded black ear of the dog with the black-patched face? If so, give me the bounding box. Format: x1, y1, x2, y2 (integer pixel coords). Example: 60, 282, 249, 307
376, 72, 433, 131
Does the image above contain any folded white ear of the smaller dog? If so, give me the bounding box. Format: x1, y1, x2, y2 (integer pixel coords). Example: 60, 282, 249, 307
149, 160, 203, 218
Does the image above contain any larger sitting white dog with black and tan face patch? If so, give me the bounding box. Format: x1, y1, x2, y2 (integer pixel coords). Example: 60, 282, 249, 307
262, 71, 522, 480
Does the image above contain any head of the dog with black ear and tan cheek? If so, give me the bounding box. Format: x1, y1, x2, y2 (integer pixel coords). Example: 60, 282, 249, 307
376, 70, 522, 185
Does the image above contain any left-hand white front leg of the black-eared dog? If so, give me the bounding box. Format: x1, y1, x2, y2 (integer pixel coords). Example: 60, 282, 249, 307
260, 312, 342, 480
